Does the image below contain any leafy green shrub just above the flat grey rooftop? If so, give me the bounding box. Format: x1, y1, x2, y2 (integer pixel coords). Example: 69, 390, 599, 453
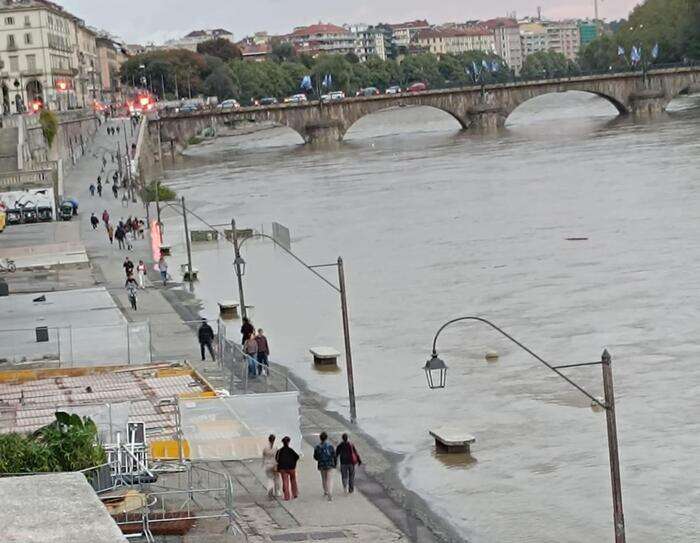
0, 412, 107, 473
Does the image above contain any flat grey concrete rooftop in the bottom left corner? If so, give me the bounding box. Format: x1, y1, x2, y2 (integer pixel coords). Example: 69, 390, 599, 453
0, 473, 127, 543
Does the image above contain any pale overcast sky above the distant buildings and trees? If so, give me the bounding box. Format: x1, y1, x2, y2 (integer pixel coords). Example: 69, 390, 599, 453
56, 0, 640, 43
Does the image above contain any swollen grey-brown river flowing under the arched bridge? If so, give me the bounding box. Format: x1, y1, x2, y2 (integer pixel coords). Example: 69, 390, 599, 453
159, 93, 700, 543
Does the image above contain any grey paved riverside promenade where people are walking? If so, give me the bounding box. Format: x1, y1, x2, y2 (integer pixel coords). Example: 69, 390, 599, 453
66, 121, 446, 543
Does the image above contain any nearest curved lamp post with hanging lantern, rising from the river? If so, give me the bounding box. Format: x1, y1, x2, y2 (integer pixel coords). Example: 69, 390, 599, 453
423, 317, 625, 543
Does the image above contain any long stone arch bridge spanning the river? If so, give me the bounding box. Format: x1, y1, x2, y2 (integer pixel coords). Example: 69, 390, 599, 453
149, 66, 700, 145
